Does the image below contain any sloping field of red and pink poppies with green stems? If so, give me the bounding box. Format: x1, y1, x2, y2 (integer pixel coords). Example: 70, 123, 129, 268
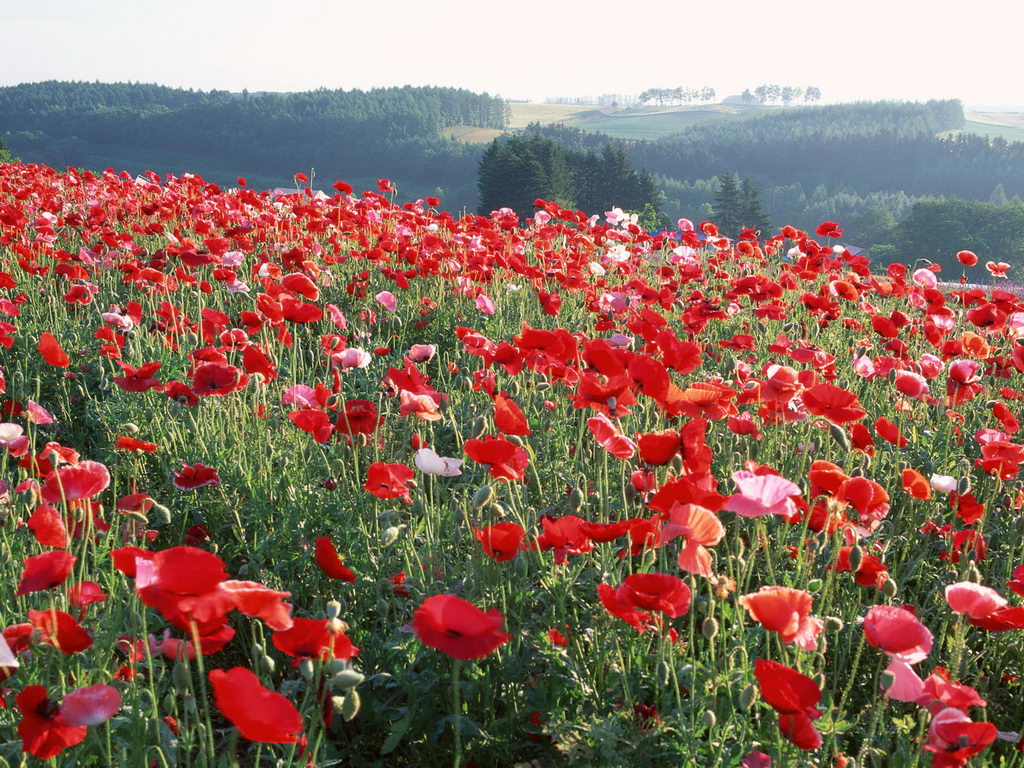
0, 164, 1024, 768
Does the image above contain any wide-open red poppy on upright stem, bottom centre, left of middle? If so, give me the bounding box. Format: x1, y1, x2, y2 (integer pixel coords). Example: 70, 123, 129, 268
413, 595, 512, 660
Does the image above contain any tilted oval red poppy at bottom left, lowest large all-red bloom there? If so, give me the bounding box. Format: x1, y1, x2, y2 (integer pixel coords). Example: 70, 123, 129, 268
209, 667, 302, 744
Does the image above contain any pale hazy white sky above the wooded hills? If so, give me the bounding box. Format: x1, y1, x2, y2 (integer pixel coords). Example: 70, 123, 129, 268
8, 0, 1024, 105
